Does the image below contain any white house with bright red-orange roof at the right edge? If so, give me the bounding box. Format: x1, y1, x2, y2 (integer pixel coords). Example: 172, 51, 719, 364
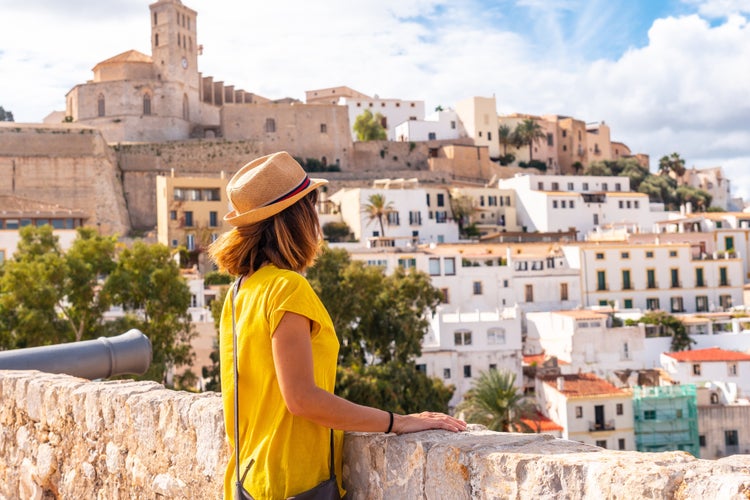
661, 347, 750, 397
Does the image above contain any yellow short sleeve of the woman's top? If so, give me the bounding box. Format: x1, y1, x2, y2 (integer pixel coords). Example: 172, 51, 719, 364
266, 271, 320, 337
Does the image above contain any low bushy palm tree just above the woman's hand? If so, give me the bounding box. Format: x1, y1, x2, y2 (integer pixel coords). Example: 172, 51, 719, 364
456, 369, 535, 432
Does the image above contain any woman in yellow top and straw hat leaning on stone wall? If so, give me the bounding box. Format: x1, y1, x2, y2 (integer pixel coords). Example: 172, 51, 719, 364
209, 152, 466, 499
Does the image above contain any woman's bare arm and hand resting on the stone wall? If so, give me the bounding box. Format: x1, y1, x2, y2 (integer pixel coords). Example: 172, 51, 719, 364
271, 312, 466, 434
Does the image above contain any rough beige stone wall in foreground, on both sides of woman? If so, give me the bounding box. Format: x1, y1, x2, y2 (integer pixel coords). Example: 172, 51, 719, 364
0, 371, 750, 500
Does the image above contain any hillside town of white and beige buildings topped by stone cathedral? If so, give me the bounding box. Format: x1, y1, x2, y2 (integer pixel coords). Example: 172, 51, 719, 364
0, 0, 750, 459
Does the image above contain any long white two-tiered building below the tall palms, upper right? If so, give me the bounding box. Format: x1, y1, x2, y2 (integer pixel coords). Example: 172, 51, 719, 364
498, 174, 664, 235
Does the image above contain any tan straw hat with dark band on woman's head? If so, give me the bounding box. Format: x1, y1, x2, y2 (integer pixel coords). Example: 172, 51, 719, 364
224, 151, 328, 227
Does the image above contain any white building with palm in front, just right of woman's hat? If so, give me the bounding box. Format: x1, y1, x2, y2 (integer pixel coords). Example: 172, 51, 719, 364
329, 179, 458, 247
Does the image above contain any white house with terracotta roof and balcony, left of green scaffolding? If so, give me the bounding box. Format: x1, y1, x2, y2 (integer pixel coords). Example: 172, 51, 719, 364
536, 373, 635, 450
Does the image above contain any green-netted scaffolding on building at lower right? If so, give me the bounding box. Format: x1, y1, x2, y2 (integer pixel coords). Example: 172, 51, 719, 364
633, 384, 700, 458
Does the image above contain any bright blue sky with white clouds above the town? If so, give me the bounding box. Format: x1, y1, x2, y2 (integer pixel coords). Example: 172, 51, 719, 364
0, 0, 750, 199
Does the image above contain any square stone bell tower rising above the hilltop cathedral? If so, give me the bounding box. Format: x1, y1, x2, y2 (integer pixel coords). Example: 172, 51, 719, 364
149, 0, 199, 89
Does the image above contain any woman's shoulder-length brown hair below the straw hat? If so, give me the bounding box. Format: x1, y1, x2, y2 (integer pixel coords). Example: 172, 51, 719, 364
208, 191, 321, 276
